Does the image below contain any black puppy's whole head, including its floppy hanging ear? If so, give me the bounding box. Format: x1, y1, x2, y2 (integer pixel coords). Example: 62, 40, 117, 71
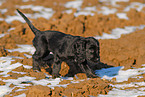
73, 37, 100, 63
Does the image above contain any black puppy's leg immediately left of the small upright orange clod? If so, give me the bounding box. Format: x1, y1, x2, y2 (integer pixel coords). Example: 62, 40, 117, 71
52, 55, 62, 78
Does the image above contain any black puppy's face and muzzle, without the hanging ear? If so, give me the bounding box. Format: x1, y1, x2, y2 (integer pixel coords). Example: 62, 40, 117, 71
86, 37, 100, 63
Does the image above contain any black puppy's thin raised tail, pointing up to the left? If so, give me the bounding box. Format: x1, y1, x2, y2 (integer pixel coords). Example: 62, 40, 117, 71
17, 9, 41, 35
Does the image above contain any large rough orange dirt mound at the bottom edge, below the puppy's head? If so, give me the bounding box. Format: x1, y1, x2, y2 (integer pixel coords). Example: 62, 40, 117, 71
63, 78, 112, 97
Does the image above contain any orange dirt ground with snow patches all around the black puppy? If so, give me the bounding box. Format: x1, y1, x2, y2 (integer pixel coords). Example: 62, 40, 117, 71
0, 0, 145, 97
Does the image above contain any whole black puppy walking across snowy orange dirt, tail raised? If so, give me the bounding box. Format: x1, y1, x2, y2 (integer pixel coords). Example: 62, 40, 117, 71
17, 9, 100, 77
